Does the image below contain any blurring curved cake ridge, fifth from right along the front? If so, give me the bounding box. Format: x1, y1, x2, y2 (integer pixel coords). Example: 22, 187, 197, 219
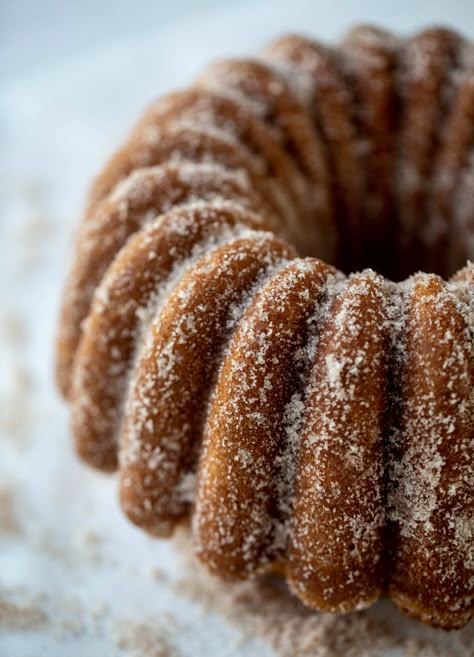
71, 201, 276, 468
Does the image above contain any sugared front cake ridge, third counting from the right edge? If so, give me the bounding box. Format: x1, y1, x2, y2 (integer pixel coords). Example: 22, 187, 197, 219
194, 259, 336, 578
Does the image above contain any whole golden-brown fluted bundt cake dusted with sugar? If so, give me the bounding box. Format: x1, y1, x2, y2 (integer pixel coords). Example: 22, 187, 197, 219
57, 26, 474, 629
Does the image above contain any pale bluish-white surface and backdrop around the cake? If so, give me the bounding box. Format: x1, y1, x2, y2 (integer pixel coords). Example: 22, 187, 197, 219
0, 0, 474, 657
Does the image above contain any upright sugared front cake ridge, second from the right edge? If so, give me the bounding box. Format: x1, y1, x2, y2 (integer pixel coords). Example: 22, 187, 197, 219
288, 272, 389, 611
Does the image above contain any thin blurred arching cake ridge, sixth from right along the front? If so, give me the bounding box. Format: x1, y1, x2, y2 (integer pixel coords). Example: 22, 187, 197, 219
57, 162, 272, 396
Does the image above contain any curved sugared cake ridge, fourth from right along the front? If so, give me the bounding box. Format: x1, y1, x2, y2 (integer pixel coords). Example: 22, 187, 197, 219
121, 234, 293, 532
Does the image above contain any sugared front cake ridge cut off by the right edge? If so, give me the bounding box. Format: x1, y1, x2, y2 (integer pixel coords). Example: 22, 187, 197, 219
389, 268, 474, 626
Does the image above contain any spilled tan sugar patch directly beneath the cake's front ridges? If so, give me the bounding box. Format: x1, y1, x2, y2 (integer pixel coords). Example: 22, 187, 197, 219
174, 532, 474, 657
